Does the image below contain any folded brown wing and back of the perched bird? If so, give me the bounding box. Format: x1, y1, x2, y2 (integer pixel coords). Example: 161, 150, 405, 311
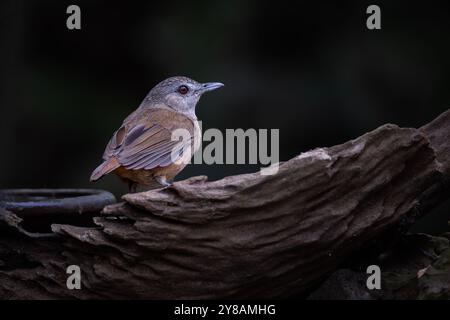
105, 109, 193, 170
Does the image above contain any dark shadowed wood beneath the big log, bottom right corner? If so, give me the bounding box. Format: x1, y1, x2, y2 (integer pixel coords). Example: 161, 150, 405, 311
308, 233, 450, 300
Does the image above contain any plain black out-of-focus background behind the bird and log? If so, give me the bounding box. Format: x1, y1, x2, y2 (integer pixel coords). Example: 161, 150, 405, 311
0, 0, 450, 232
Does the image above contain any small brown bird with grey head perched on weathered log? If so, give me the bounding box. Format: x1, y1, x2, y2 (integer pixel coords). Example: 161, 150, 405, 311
91, 77, 223, 191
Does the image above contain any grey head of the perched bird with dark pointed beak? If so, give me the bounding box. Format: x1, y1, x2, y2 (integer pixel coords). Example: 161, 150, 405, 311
146, 77, 224, 116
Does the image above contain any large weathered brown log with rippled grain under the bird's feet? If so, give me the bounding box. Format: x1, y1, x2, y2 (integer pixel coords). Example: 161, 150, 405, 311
0, 112, 450, 299
